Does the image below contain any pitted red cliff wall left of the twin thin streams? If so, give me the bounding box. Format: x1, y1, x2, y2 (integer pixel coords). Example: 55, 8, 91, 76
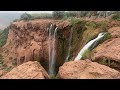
3, 20, 52, 65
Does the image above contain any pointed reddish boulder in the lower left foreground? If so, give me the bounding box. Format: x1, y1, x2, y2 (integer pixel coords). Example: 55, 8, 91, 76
0, 61, 49, 79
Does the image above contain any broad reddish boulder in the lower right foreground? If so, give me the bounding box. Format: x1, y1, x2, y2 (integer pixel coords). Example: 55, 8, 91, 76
58, 60, 120, 79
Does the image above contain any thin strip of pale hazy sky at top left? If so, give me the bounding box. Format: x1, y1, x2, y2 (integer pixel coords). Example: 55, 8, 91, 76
0, 11, 52, 13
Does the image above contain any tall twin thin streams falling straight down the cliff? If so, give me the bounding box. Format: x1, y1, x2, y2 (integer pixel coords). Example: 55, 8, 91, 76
49, 24, 58, 74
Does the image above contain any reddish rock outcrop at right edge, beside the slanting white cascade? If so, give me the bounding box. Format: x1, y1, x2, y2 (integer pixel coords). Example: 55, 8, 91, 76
91, 27, 120, 70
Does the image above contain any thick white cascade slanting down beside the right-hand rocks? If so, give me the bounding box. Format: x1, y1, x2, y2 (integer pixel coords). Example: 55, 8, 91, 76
75, 33, 105, 61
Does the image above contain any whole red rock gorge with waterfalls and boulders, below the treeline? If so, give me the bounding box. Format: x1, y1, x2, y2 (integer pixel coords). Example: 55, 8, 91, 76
0, 12, 120, 79
